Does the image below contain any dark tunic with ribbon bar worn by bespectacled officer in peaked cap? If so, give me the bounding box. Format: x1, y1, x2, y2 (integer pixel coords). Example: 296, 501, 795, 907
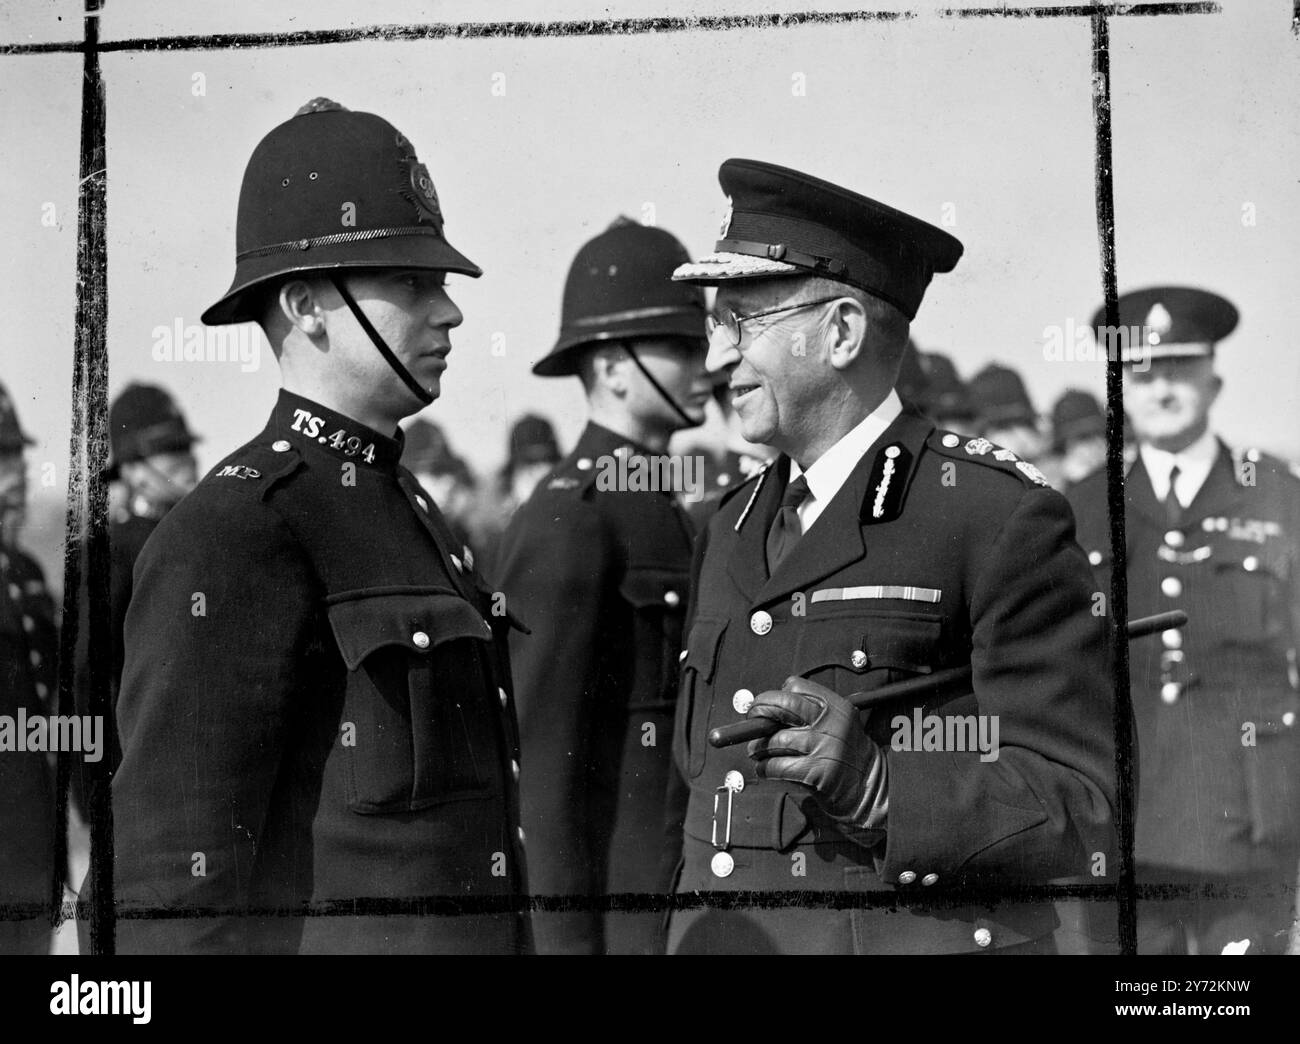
668, 410, 1118, 953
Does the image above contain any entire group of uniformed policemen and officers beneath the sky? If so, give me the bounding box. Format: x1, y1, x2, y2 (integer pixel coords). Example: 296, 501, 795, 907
0, 99, 1300, 953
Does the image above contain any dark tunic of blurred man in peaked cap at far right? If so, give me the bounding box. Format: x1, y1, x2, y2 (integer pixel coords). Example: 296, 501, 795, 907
1070, 443, 1300, 937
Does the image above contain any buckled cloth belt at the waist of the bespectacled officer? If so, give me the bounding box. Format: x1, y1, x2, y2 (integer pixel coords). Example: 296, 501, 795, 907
685, 783, 821, 852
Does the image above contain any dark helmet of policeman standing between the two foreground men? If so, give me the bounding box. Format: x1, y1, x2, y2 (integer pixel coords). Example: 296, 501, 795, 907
533, 217, 706, 377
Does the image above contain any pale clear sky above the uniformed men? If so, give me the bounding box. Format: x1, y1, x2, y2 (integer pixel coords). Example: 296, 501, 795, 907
0, 0, 1300, 579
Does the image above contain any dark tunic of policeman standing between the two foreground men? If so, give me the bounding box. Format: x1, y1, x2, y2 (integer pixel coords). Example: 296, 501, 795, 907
501, 424, 692, 953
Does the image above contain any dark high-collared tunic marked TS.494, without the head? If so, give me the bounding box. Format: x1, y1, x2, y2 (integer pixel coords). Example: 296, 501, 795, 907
113, 391, 528, 953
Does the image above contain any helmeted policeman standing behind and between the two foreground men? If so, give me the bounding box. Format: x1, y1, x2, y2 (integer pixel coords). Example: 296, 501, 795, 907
499, 218, 711, 953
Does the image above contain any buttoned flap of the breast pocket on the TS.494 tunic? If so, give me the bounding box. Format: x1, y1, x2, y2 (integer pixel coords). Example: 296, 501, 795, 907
329, 593, 491, 671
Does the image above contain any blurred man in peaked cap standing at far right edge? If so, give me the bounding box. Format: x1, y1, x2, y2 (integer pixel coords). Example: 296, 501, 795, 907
1070, 286, 1300, 953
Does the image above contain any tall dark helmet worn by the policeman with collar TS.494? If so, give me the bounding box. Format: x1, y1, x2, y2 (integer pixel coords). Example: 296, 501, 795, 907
203, 98, 482, 326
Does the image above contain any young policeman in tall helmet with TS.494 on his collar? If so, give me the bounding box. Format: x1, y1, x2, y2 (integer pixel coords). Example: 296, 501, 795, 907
102, 99, 528, 953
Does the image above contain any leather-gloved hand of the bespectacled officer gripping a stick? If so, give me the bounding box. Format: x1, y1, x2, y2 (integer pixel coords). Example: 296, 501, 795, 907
746, 677, 889, 845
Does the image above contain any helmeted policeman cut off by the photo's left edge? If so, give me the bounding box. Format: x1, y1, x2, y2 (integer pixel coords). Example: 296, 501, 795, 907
0, 385, 59, 954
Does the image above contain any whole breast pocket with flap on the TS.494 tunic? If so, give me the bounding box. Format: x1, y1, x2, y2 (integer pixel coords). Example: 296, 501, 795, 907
329, 593, 498, 813
